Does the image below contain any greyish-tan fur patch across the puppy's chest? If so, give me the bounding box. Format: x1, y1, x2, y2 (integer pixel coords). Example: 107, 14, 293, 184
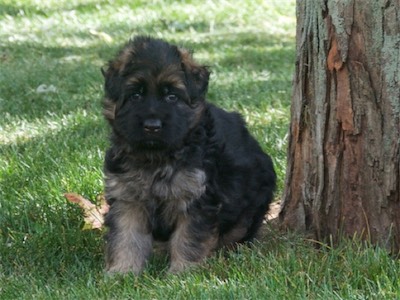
106, 166, 206, 209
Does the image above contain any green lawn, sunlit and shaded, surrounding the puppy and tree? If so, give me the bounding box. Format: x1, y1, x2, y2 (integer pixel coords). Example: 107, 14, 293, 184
0, 0, 400, 299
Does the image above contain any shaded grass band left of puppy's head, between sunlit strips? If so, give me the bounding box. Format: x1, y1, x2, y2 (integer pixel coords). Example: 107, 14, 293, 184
0, 42, 115, 123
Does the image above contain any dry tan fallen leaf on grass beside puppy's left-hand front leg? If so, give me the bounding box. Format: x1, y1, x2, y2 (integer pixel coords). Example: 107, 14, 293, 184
64, 193, 109, 230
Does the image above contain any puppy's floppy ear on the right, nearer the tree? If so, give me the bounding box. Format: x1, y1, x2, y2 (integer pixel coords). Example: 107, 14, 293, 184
179, 49, 210, 102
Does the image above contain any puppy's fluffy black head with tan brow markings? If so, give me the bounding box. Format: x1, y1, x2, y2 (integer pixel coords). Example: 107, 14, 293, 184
103, 37, 209, 151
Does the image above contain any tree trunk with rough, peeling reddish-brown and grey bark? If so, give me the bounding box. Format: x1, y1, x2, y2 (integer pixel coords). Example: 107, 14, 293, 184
280, 0, 400, 251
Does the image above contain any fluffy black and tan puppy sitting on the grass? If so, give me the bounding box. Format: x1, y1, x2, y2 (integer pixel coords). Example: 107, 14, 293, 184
103, 36, 276, 274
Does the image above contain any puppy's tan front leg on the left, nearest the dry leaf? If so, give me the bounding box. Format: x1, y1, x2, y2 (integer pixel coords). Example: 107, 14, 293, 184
106, 201, 152, 275
